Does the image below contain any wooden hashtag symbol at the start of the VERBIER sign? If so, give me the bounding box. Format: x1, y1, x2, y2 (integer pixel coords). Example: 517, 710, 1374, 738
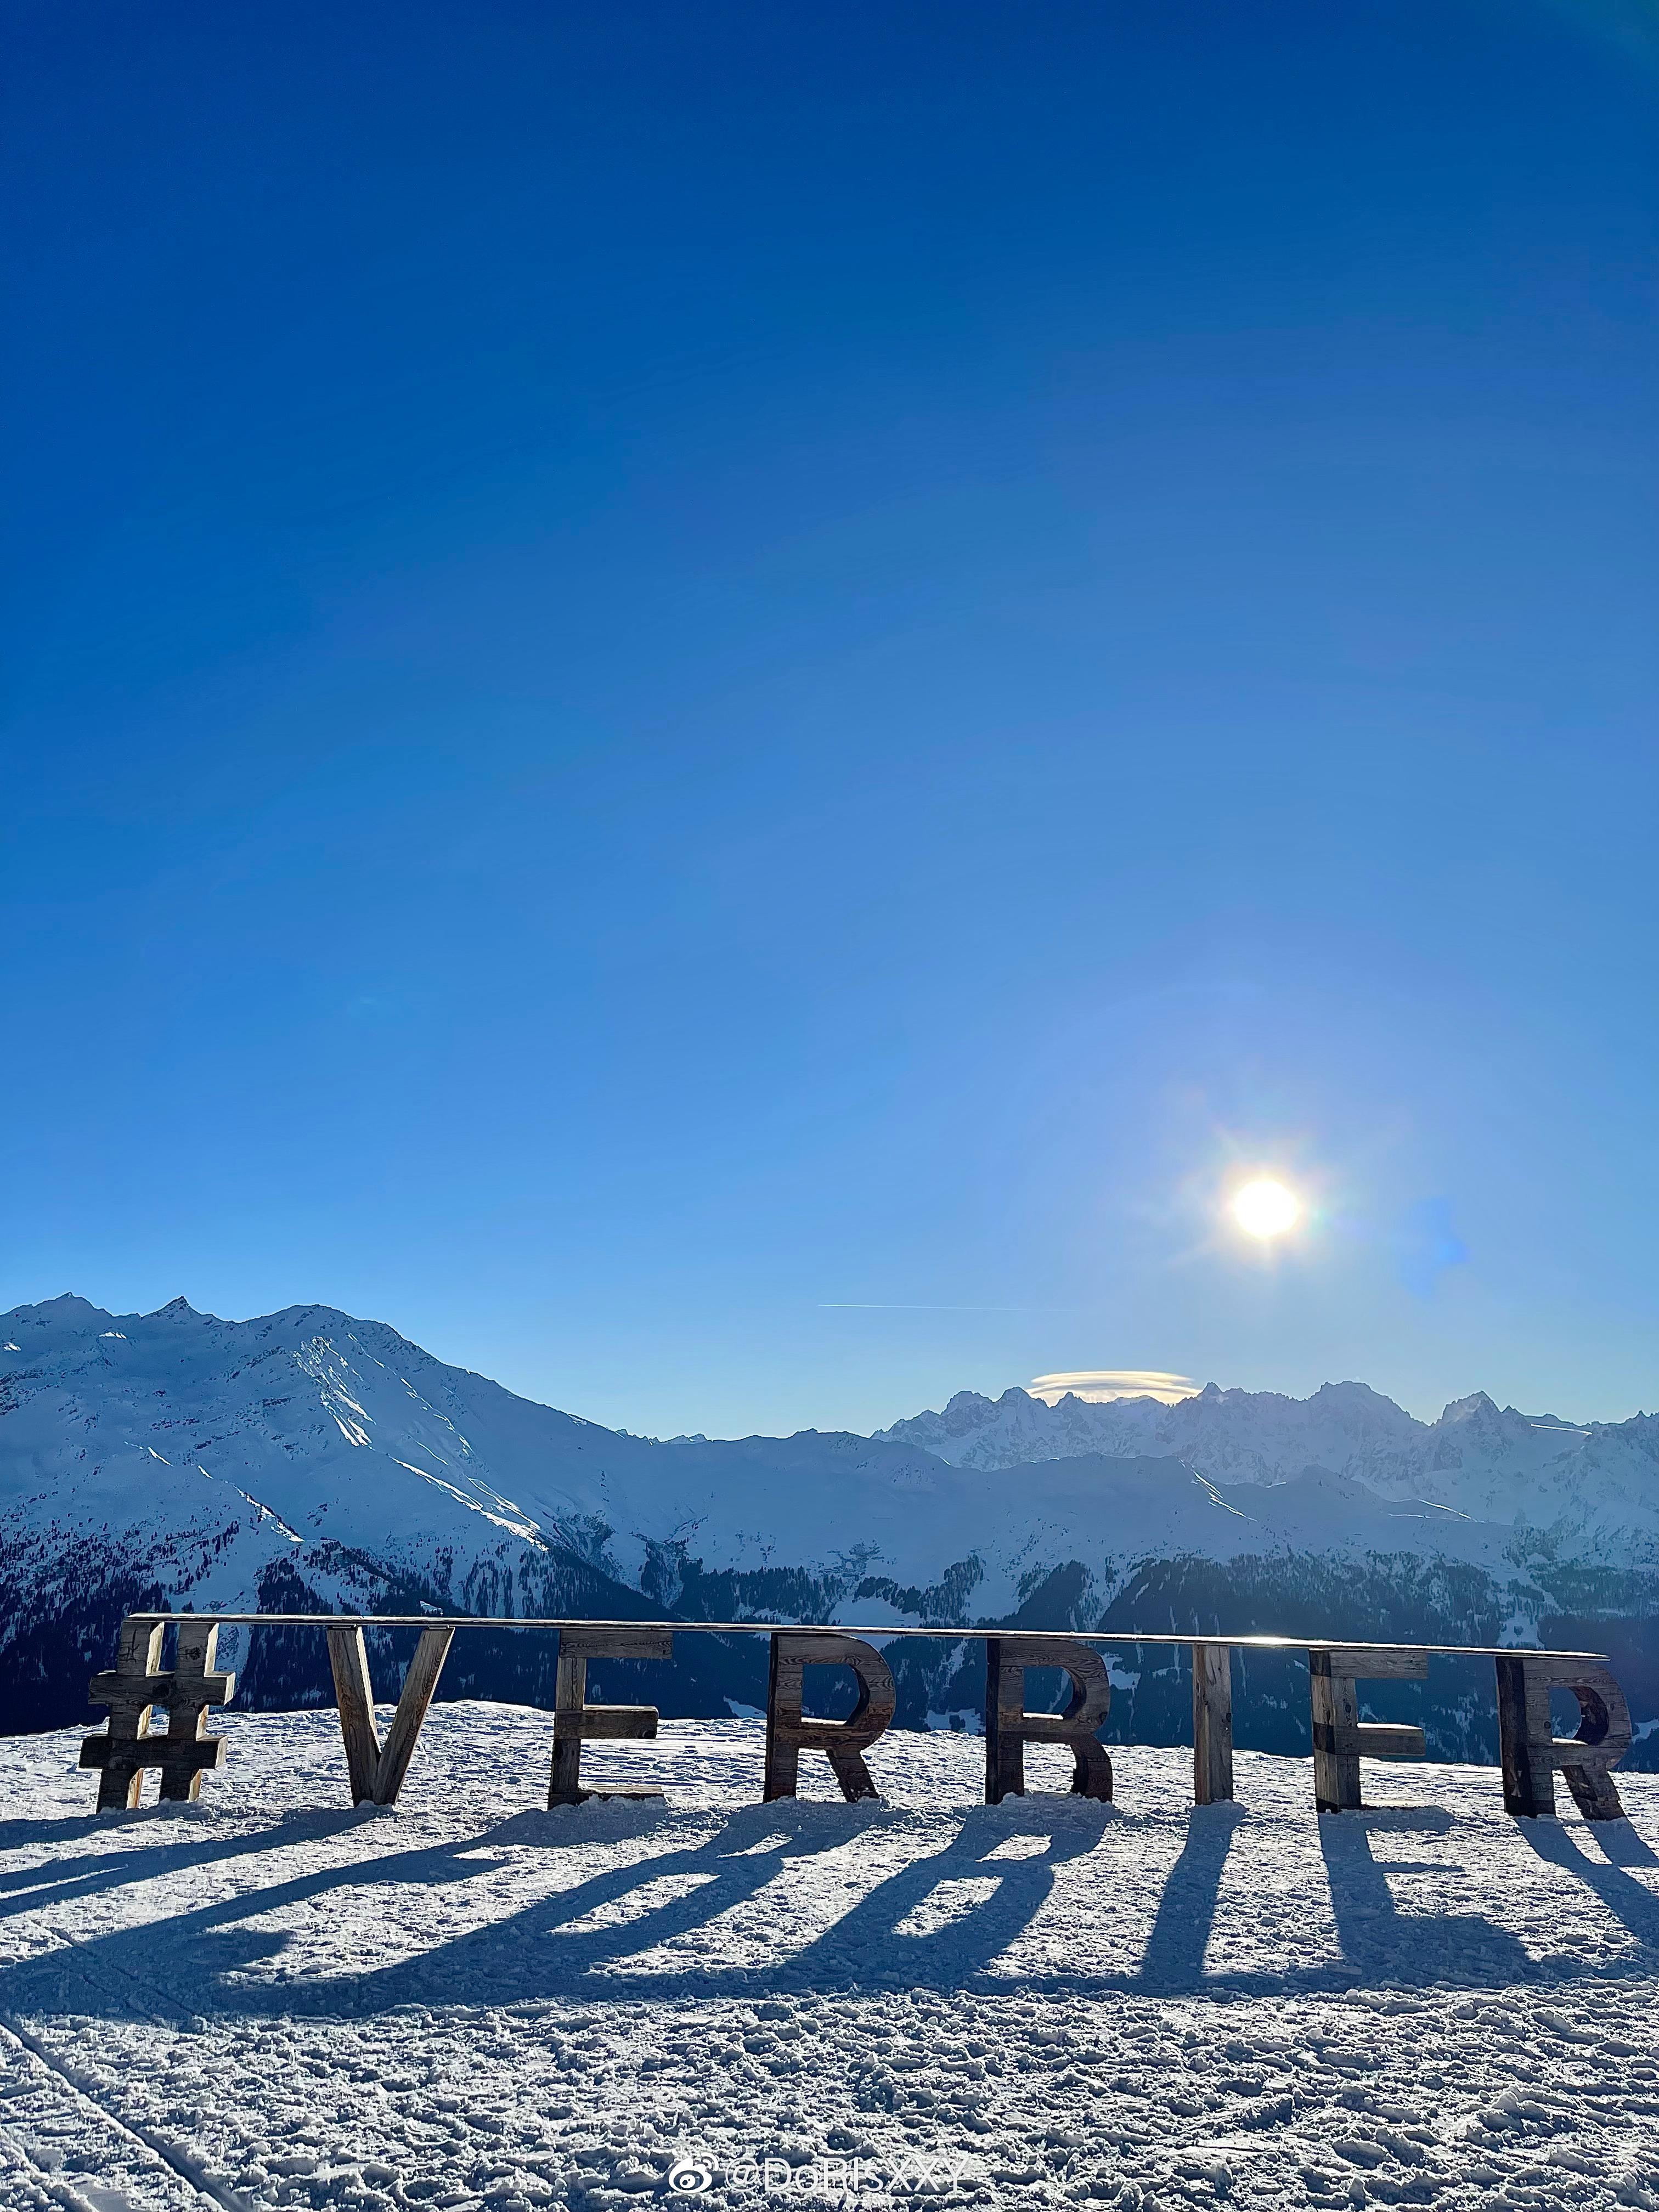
80, 1615, 236, 1812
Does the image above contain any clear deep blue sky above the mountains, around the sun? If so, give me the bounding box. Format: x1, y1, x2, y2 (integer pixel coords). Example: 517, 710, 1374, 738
0, 0, 1659, 1434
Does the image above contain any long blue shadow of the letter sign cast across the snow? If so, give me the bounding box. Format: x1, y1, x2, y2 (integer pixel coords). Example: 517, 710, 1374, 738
0, 1798, 1659, 2024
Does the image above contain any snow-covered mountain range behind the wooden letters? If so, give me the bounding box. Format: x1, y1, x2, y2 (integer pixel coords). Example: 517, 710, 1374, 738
0, 1296, 1659, 1765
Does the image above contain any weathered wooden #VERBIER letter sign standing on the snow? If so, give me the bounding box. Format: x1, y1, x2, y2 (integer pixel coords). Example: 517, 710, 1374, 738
80, 1612, 1633, 1820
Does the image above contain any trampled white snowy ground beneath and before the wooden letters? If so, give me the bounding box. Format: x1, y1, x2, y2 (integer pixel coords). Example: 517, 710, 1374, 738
0, 1706, 1659, 2212
